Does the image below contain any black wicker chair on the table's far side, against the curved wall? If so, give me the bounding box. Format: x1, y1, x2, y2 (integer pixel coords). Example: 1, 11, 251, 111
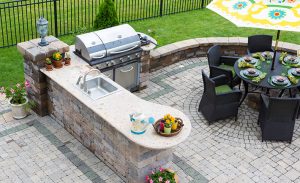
247, 35, 274, 55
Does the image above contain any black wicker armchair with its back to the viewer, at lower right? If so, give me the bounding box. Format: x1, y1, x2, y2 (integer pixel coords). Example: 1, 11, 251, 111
258, 94, 299, 143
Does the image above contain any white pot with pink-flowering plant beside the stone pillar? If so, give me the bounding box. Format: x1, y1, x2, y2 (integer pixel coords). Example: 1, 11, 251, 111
0, 81, 30, 119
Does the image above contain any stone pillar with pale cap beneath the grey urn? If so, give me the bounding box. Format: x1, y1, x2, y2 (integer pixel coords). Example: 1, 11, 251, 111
17, 36, 69, 116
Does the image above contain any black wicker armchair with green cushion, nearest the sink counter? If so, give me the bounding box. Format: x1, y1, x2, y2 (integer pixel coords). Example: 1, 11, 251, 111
198, 70, 242, 124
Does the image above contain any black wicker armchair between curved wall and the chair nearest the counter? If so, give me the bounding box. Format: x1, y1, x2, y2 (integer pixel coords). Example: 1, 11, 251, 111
207, 45, 241, 86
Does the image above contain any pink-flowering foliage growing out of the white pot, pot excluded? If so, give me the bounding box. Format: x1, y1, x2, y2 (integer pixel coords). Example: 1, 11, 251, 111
0, 81, 30, 104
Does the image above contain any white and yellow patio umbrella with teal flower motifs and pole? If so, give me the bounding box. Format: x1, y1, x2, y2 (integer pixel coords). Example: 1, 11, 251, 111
207, 0, 300, 70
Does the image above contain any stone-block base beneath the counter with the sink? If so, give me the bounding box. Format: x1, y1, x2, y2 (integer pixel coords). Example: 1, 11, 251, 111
47, 78, 172, 183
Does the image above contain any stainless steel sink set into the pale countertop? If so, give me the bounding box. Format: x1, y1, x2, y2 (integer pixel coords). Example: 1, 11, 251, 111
81, 76, 119, 100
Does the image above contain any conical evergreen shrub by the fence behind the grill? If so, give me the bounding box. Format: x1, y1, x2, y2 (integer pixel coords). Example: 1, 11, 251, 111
94, 0, 119, 29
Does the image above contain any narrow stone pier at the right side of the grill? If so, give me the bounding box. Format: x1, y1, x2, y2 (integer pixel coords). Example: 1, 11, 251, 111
139, 50, 150, 90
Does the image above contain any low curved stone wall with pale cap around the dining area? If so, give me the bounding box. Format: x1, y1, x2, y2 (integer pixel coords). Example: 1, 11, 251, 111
149, 37, 300, 72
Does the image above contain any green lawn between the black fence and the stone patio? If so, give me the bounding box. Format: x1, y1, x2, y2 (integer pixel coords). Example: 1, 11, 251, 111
0, 9, 300, 86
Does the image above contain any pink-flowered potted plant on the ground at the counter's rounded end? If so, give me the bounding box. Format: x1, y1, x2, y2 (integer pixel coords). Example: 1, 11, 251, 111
146, 168, 179, 183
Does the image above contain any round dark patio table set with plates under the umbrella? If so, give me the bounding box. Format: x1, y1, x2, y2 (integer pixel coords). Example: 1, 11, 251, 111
234, 53, 300, 105
